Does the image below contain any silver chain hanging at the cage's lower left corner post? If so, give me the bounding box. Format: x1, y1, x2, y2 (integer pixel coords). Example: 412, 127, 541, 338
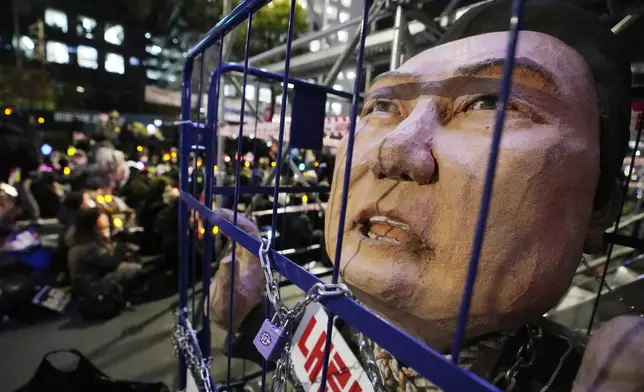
172, 309, 214, 392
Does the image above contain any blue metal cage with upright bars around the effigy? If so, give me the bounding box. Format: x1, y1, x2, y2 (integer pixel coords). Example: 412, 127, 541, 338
177, 0, 639, 391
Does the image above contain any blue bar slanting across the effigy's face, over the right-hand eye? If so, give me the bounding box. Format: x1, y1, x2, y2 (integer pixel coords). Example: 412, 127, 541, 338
452, 0, 524, 365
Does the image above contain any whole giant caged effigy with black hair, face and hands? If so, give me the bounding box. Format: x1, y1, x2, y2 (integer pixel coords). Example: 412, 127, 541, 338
209, 1, 644, 392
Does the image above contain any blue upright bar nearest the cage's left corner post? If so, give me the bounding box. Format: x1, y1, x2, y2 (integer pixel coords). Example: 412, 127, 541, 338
200, 39, 224, 356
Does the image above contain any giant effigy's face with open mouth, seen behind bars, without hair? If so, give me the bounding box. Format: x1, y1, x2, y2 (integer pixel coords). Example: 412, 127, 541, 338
325, 31, 599, 350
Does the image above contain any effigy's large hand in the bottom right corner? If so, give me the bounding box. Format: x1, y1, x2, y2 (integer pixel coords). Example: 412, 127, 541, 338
573, 316, 644, 392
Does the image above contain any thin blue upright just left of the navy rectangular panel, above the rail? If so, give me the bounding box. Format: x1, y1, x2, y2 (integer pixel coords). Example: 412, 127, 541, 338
270, 0, 295, 246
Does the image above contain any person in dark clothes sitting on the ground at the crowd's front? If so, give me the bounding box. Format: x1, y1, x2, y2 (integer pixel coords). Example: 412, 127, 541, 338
66, 208, 141, 296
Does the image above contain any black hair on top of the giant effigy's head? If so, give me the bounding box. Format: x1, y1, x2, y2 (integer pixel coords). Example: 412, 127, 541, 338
439, 0, 631, 209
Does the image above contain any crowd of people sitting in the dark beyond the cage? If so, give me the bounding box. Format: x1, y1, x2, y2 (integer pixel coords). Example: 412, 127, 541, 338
0, 112, 333, 317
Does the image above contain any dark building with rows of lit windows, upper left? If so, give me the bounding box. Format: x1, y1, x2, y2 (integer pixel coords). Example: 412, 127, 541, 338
0, 0, 146, 111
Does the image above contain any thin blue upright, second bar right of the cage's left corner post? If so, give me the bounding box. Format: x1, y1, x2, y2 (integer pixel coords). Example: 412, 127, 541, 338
226, 13, 253, 388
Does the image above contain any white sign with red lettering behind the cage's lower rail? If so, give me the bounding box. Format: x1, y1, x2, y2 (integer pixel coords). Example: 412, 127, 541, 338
291, 304, 374, 392
